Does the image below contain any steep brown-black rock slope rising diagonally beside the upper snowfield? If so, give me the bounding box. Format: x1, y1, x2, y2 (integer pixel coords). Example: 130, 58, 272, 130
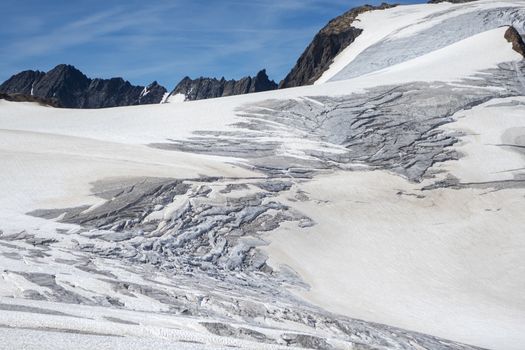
279, 3, 395, 89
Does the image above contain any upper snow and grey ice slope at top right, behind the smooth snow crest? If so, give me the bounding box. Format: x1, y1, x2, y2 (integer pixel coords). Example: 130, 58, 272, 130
316, 0, 525, 84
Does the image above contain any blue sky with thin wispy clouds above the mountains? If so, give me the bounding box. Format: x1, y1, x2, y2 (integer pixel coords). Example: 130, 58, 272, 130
0, 0, 423, 90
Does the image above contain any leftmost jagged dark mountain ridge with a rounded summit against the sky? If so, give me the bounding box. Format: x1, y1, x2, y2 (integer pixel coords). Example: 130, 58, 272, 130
0, 64, 166, 108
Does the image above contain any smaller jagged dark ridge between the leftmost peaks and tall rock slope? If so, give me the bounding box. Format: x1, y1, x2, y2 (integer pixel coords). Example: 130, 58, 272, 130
170, 69, 277, 101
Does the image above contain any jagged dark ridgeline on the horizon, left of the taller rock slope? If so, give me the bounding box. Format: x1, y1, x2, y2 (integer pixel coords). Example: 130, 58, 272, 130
0, 64, 277, 108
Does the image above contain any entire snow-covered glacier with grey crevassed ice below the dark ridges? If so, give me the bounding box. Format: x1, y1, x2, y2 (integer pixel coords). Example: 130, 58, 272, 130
0, 0, 525, 350
